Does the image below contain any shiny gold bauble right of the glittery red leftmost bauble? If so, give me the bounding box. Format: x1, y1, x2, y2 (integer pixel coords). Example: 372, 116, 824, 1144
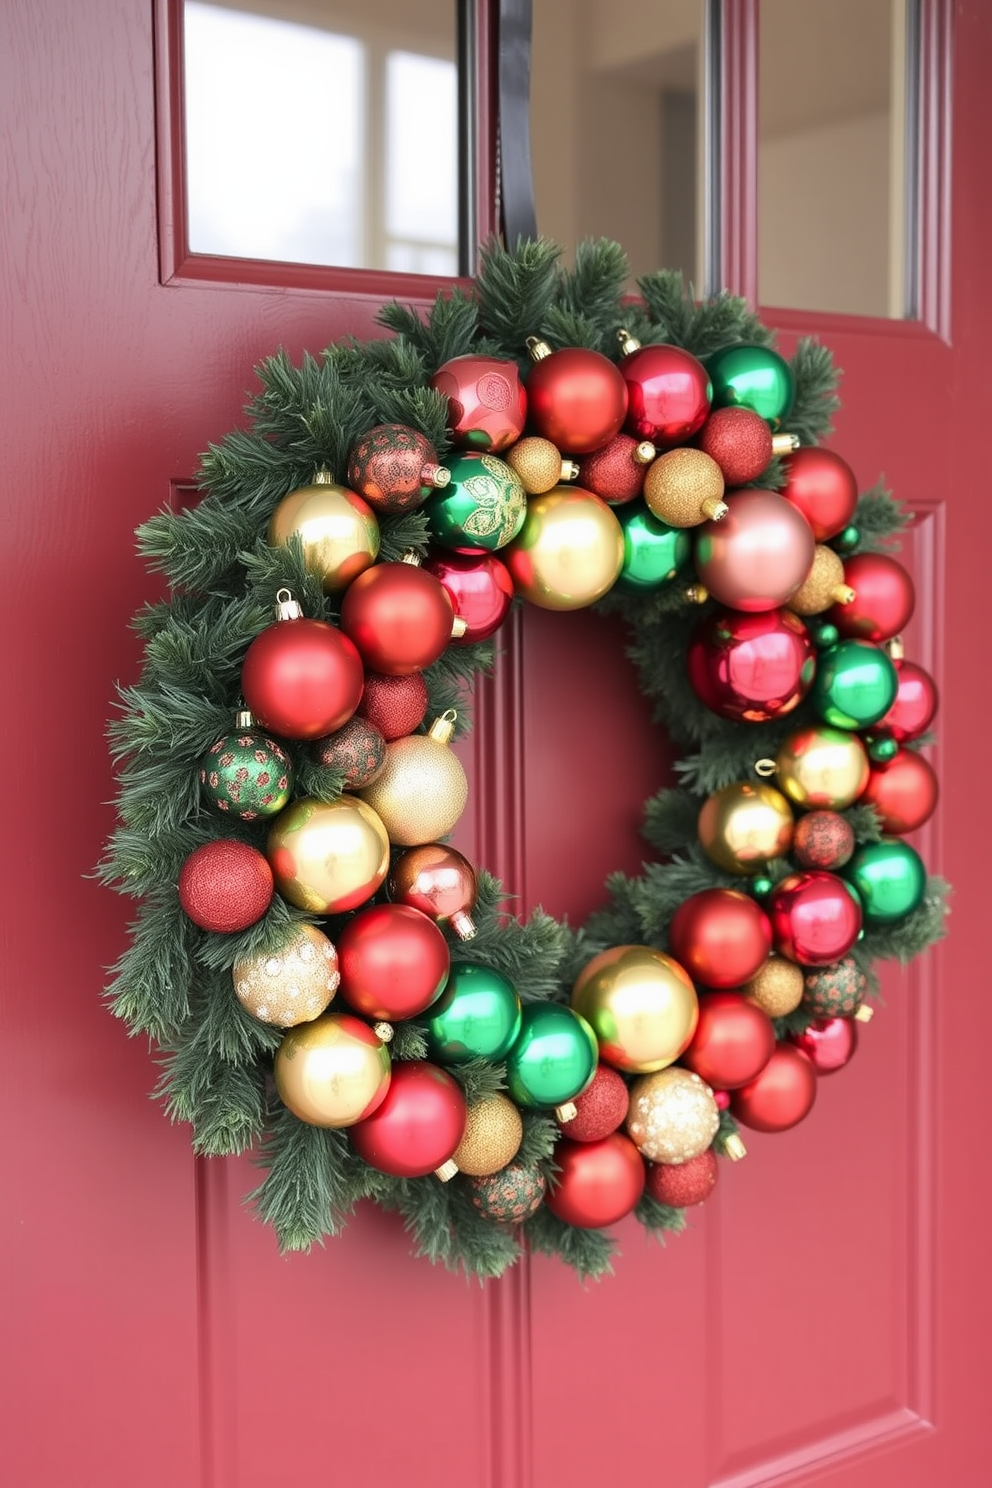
265, 796, 390, 915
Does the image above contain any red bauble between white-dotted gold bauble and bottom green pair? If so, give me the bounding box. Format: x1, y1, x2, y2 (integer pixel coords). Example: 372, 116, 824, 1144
338, 905, 451, 1022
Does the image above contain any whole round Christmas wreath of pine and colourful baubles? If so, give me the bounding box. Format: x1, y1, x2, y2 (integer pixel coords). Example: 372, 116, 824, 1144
101, 240, 946, 1275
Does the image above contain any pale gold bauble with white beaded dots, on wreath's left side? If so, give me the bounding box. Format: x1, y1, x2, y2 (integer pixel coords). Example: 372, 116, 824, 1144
231, 924, 341, 1028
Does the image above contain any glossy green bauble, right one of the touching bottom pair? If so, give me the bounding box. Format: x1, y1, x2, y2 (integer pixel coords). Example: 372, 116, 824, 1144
506, 1003, 599, 1107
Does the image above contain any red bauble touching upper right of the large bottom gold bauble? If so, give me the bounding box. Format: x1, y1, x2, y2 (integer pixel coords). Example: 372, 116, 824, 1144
668, 888, 772, 990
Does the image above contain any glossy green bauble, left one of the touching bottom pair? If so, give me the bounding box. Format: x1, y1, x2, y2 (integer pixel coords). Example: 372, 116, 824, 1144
424, 963, 521, 1064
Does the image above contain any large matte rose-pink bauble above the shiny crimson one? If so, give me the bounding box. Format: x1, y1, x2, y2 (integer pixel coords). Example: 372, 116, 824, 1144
695, 487, 817, 615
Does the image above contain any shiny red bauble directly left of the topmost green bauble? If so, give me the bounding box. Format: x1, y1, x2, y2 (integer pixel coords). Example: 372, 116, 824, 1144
620, 345, 712, 449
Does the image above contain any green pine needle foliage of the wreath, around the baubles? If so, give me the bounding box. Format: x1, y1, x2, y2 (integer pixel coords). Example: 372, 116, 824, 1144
98, 238, 949, 1278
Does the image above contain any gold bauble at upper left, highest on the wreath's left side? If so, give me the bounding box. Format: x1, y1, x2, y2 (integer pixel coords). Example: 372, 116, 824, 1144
269, 470, 379, 594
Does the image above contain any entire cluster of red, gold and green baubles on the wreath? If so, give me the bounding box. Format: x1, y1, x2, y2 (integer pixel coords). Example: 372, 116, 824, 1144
178, 333, 937, 1228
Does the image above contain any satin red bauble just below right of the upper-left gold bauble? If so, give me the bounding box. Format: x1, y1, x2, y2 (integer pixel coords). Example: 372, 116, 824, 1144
339, 562, 455, 675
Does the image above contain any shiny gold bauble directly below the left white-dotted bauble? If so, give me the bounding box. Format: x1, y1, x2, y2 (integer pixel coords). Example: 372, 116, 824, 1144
274, 1013, 393, 1126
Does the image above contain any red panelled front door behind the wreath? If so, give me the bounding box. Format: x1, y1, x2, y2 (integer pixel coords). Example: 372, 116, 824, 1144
0, 0, 992, 1488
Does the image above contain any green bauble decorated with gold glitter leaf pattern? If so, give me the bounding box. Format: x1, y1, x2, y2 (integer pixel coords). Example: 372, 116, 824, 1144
424, 454, 526, 554
